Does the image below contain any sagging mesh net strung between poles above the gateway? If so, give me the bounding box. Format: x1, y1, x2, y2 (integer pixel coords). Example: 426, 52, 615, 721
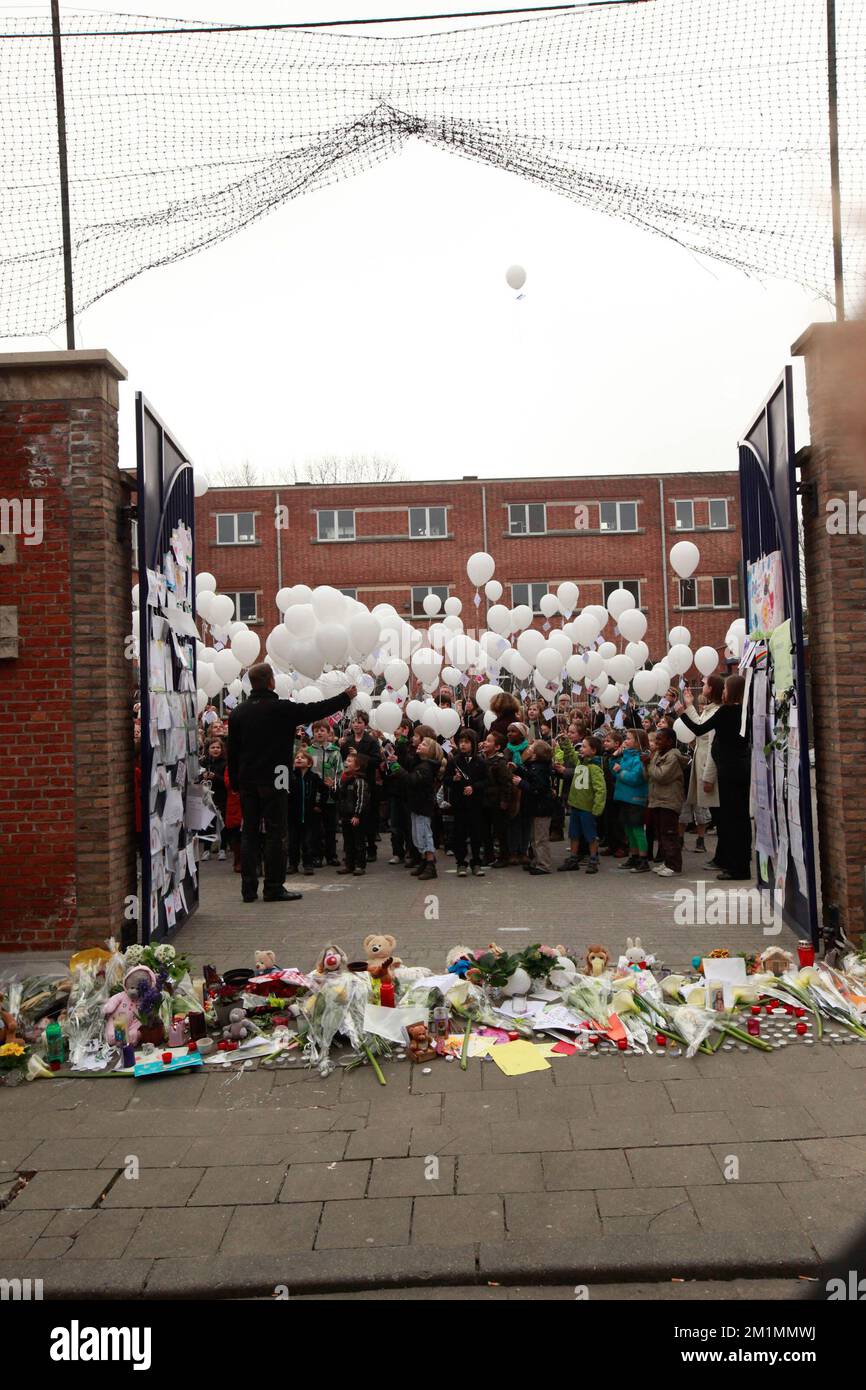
0, 0, 866, 336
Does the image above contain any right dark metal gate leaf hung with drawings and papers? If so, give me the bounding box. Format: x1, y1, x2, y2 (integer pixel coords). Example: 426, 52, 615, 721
740, 367, 819, 947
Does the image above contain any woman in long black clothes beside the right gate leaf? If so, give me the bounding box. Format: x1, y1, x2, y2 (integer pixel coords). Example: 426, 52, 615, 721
678, 676, 753, 880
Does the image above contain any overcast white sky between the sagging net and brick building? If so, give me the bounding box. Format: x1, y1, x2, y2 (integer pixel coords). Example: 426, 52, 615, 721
3, 0, 831, 481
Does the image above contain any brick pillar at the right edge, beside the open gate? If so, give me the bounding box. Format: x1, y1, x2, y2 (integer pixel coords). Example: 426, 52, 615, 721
791, 321, 866, 937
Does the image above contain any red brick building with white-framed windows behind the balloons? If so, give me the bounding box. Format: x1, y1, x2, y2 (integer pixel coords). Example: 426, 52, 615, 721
196, 471, 740, 660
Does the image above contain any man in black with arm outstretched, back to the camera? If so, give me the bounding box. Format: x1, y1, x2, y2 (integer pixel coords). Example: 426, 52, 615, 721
228, 662, 357, 902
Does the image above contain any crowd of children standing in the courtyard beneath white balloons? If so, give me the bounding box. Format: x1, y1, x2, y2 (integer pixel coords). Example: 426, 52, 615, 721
195, 677, 724, 880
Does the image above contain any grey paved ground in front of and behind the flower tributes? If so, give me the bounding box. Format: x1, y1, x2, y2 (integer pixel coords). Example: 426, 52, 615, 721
0, 841, 866, 1298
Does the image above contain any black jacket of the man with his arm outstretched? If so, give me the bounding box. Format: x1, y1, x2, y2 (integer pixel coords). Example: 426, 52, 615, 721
228, 691, 350, 791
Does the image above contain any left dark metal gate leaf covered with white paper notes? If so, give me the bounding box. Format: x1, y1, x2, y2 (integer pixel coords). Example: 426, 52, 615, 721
135, 392, 199, 942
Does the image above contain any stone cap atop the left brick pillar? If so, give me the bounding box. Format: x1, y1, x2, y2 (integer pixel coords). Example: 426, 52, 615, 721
0, 348, 126, 410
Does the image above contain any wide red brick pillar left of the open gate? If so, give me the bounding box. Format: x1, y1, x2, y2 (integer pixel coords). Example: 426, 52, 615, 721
0, 349, 135, 951
